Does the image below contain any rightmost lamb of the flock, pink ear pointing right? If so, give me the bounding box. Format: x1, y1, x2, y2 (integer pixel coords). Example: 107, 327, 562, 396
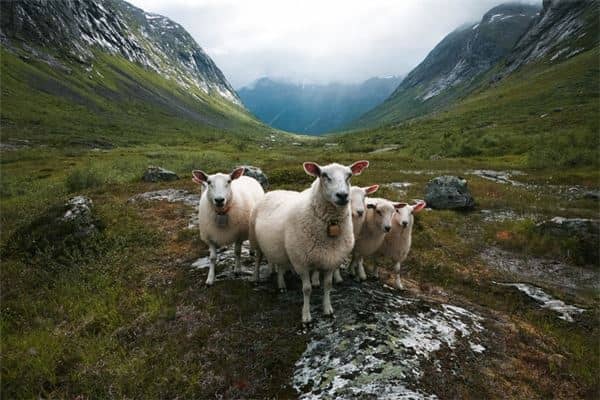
377, 200, 427, 289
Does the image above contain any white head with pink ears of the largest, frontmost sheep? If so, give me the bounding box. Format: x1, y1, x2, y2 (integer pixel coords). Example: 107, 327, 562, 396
304, 161, 369, 207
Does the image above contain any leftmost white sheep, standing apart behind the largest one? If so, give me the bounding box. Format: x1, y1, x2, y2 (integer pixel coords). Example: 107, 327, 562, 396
192, 167, 265, 286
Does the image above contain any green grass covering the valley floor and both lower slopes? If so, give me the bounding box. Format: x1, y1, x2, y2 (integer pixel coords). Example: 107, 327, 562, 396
0, 35, 600, 398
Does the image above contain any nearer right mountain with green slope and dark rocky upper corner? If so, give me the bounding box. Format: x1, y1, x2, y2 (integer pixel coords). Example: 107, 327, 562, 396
338, 0, 600, 167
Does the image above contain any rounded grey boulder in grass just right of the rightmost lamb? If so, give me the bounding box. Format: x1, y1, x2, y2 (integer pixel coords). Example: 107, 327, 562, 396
425, 175, 475, 209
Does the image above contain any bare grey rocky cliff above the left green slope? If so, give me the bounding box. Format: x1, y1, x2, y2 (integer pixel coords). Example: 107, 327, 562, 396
0, 0, 241, 105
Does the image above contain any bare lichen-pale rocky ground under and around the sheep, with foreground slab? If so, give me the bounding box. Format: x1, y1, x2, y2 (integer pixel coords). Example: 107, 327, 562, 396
129, 166, 600, 399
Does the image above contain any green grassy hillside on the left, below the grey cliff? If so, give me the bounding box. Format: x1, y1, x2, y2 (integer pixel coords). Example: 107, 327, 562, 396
0, 48, 270, 144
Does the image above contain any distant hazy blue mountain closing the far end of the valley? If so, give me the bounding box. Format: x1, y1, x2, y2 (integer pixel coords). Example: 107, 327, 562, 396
238, 76, 402, 135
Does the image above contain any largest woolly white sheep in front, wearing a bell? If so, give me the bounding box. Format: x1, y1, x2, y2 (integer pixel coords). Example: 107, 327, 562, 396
250, 161, 369, 324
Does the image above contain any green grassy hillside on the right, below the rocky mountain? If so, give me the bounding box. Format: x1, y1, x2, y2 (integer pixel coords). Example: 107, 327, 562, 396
337, 48, 600, 167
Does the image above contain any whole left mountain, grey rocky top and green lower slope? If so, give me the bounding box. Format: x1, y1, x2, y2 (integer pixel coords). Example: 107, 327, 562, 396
0, 0, 260, 144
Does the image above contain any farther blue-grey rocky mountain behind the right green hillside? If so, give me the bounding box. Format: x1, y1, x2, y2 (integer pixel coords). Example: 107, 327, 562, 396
357, 4, 539, 126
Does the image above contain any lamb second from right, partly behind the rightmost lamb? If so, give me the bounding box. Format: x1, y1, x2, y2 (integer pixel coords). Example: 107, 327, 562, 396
350, 198, 402, 281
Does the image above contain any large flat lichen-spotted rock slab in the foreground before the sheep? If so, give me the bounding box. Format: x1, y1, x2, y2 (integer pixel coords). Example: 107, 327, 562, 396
292, 282, 488, 399
